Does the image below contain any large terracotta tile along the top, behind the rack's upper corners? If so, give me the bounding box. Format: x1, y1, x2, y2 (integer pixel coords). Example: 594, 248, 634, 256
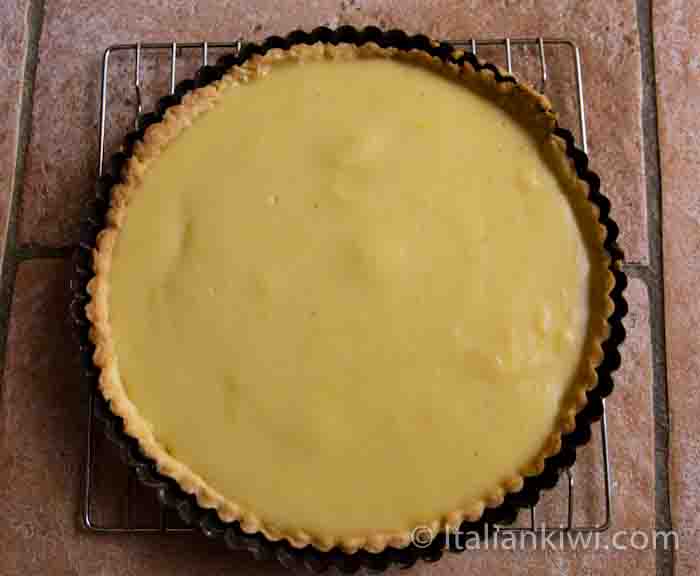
20, 0, 647, 261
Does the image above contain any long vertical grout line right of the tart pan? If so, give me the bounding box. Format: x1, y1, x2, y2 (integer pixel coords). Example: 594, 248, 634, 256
637, 0, 675, 576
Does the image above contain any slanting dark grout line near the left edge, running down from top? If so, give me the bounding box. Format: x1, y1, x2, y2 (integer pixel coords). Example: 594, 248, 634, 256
0, 0, 46, 382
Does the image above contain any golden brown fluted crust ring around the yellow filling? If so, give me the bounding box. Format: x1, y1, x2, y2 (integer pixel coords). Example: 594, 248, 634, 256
86, 43, 614, 553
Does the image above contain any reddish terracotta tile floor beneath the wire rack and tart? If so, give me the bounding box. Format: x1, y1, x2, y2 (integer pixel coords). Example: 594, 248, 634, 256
0, 0, 700, 576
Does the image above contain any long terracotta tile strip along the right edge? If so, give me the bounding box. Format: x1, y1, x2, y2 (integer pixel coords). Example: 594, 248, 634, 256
653, 0, 700, 575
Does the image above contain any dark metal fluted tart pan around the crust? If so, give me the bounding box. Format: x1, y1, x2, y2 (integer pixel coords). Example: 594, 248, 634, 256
71, 26, 627, 573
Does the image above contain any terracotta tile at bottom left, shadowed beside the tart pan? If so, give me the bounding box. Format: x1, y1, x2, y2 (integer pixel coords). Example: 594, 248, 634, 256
0, 260, 283, 576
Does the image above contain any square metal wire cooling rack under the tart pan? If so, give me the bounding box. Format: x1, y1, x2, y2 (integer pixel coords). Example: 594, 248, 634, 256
81, 37, 612, 534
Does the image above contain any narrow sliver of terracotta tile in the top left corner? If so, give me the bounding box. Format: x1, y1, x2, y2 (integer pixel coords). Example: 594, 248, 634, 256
0, 0, 29, 265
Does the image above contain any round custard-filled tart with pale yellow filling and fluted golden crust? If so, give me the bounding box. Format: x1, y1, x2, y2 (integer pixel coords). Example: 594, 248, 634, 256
86, 37, 614, 553
